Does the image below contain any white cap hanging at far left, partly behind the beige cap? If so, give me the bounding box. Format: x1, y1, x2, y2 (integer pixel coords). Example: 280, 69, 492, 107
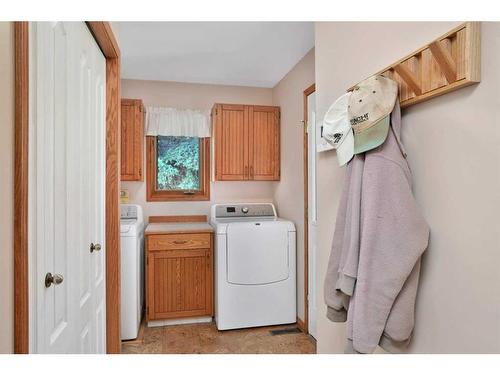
323, 92, 354, 166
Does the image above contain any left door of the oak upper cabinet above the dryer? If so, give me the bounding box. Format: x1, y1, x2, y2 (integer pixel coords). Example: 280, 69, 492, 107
214, 104, 249, 181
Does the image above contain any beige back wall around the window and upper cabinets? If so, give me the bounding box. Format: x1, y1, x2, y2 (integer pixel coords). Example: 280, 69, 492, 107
122, 80, 275, 218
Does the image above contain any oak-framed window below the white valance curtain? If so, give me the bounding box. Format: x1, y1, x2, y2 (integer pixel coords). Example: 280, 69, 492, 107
146, 136, 210, 201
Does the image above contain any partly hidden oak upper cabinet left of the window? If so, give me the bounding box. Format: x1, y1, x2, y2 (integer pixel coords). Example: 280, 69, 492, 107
121, 99, 144, 181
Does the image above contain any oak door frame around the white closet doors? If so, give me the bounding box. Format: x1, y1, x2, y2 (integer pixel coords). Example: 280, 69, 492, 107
14, 21, 121, 354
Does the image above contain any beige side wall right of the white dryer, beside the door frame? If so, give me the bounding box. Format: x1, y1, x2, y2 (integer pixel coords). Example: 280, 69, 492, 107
273, 49, 314, 320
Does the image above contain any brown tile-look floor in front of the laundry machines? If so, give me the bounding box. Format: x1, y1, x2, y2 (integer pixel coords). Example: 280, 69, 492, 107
122, 323, 316, 354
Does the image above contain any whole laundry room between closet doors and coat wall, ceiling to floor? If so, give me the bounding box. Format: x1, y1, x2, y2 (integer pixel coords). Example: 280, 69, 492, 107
116, 22, 315, 353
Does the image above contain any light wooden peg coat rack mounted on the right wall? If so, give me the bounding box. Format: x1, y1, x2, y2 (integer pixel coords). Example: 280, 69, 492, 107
348, 22, 481, 108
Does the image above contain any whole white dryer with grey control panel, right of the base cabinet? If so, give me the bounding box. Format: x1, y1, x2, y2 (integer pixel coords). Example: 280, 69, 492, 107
211, 203, 297, 330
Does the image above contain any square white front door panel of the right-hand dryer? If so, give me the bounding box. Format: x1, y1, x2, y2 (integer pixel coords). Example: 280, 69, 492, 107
226, 221, 290, 285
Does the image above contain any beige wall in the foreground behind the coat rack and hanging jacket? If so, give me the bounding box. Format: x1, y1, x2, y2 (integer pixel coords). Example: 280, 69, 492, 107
316, 22, 500, 353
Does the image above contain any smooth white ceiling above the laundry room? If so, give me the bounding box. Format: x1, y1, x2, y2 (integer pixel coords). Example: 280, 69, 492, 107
118, 22, 314, 87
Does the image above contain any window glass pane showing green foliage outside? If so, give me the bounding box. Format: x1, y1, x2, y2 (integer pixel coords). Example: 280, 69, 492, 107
156, 136, 200, 190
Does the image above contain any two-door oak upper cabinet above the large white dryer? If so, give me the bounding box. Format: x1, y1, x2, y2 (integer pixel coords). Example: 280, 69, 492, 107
212, 104, 280, 181
